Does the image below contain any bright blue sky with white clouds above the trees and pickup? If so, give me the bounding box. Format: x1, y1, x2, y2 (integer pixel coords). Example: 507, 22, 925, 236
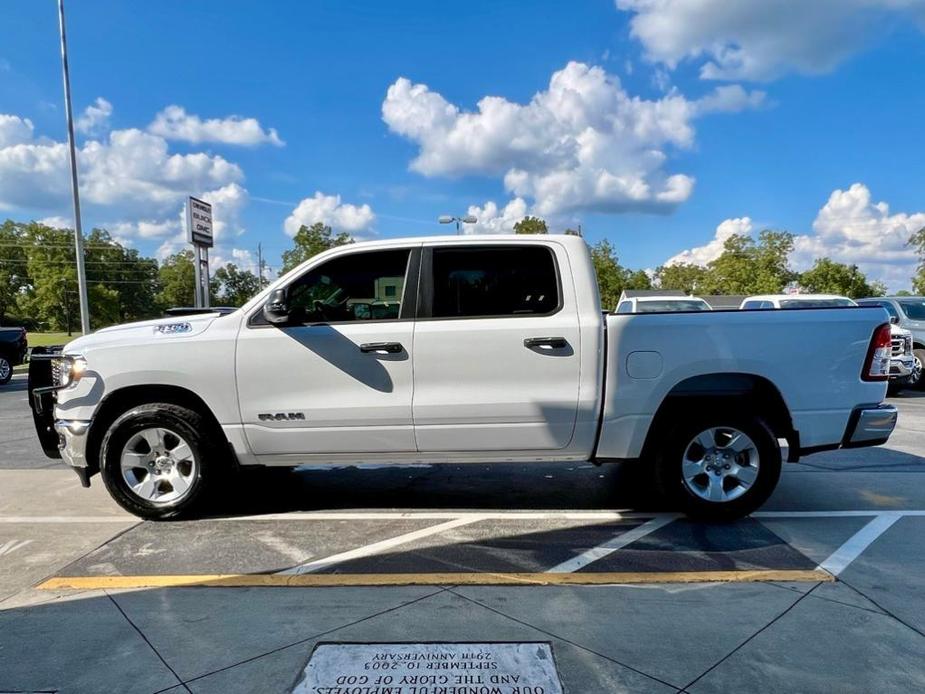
0, 0, 925, 290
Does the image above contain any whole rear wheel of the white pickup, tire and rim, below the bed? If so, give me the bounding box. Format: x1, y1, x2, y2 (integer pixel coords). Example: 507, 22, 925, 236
656, 413, 781, 521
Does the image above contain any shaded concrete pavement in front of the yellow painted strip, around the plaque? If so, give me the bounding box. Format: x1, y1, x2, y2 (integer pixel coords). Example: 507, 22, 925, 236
0, 564, 925, 694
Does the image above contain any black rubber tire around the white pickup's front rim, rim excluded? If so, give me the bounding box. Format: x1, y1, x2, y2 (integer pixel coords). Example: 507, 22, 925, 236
100, 403, 220, 520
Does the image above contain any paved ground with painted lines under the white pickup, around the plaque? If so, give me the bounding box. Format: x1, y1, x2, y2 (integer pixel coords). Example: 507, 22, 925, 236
0, 376, 925, 693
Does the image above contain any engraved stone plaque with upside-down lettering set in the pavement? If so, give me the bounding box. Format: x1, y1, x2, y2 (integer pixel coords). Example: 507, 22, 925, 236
292, 643, 562, 694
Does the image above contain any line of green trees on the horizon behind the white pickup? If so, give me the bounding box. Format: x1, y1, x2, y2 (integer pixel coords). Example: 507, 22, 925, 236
0, 217, 925, 331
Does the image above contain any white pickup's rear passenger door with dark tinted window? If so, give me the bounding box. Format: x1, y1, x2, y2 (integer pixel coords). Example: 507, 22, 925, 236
413, 243, 580, 452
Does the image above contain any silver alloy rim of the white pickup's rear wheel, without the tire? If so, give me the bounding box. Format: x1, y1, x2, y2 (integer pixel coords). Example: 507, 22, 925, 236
681, 427, 759, 503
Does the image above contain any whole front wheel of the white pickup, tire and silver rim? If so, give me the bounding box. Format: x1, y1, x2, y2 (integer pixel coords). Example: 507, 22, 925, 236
100, 403, 223, 520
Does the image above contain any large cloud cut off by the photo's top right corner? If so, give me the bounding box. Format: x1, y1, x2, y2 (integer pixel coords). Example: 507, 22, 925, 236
616, 0, 925, 80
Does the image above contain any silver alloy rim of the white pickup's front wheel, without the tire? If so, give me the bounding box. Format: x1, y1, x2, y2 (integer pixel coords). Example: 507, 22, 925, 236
121, 427, 198, 504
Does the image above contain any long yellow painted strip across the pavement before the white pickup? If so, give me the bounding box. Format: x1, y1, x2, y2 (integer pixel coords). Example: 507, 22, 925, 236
36, 569, 835, 590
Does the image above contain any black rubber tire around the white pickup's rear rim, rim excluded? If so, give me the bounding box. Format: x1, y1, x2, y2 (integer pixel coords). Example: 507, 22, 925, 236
655, 411, 781, 522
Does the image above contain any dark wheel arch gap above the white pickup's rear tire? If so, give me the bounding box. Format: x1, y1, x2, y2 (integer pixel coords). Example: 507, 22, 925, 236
643, 373, 800, 462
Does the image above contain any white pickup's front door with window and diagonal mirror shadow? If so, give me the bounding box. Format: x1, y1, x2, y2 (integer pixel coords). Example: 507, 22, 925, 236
236, 248, 418, 456
